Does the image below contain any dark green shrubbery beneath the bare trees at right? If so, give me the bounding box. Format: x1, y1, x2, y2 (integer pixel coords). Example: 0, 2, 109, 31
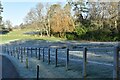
74, 29, 120, 41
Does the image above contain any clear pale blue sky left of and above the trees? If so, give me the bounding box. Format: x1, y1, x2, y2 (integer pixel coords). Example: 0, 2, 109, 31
1, 0, 66, 26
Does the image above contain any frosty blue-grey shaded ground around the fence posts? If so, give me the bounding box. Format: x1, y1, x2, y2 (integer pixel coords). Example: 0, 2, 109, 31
0, 40, 117, 78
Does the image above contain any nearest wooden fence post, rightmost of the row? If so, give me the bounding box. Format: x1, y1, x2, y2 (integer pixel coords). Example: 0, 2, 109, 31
113, 46, 119, 80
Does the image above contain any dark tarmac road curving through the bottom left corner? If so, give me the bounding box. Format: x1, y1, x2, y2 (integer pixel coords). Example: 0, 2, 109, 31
0, 55, 19, 78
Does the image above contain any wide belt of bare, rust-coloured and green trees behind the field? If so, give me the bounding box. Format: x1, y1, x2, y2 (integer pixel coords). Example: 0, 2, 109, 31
16, 0, 120, 41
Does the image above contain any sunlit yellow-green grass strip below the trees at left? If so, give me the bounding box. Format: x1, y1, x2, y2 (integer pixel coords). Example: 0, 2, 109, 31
0, 29, 65, 44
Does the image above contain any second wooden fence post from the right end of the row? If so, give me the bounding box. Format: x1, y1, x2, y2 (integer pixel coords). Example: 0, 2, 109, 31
83, 47, 87, 77
